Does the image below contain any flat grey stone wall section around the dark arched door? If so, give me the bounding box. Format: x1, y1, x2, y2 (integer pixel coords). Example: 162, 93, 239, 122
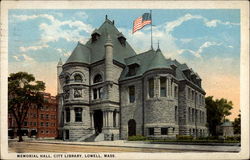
120, 80, 143, 139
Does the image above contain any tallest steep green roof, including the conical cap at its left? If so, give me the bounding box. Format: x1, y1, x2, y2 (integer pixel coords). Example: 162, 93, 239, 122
63, 19, 136, 64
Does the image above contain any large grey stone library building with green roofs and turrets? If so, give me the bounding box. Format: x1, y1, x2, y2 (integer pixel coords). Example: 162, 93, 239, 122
57, 16, 207, 141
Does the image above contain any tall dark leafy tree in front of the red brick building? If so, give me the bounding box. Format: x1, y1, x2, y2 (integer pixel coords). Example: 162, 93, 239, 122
8, 72, 45, 142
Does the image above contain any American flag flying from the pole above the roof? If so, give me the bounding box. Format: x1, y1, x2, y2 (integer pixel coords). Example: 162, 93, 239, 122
133, 13, 152, 33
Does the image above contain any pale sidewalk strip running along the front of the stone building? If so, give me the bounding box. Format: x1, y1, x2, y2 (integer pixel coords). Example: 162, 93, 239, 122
16, 139, 240, 152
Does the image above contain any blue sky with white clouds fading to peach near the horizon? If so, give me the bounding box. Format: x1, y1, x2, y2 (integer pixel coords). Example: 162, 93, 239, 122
8, 9, 240, 120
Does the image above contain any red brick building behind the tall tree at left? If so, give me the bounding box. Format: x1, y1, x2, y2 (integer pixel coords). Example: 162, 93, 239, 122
8, 93, 58, 138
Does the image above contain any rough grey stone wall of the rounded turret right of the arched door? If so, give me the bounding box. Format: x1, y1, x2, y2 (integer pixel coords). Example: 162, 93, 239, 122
144, 72, 179, 138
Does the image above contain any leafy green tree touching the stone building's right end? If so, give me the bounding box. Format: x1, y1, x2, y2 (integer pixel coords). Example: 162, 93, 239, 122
205, 96, 233, 136
